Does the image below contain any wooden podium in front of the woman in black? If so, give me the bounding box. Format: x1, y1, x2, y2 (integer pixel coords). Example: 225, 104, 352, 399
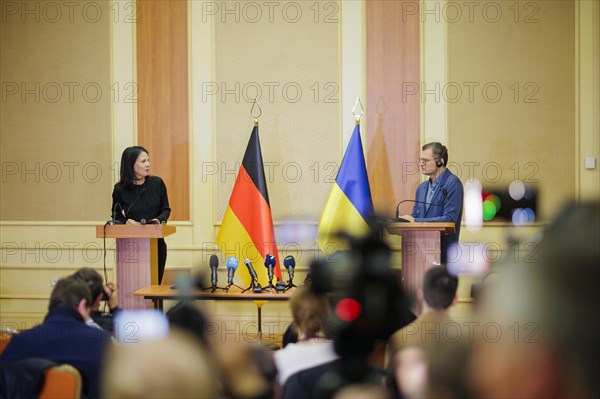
96, 224, 176, 309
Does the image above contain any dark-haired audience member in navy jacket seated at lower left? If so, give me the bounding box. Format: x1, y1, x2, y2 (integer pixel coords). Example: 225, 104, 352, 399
0, 276, 110, 398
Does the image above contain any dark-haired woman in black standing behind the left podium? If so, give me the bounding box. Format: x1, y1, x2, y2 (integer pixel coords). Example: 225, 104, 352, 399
112, 146, 171, 284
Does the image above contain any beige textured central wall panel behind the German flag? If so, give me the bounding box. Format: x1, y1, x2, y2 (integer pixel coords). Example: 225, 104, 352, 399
213, 1, 340, 221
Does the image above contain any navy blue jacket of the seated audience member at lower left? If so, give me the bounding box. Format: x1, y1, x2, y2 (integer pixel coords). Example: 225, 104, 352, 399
0, 305, 110, 398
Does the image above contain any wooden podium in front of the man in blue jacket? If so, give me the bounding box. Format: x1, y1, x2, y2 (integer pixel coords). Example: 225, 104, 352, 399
386, 223, 454, 304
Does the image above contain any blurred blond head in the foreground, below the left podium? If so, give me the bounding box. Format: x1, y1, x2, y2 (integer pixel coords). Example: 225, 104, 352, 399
102, 328, 216, 399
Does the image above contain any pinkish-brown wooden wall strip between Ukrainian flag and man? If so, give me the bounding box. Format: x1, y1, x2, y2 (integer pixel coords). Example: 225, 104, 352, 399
365, 1, 420, 216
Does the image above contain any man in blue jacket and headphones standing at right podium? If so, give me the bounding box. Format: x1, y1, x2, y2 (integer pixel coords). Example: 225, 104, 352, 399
401, 142, 463, 263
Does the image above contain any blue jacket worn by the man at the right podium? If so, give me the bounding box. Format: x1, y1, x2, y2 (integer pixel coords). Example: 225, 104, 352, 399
411, 169, 463, 263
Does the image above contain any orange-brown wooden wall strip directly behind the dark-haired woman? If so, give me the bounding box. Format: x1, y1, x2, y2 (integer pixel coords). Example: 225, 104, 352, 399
136, 0, 190, 220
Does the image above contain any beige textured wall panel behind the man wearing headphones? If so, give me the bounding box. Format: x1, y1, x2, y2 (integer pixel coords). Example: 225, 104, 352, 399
450, 1, 576, 220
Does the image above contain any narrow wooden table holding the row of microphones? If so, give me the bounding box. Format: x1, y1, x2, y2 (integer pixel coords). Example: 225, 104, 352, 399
133, 285, 293, 338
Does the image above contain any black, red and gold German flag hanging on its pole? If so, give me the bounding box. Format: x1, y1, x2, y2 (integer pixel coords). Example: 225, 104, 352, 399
217, 126, 283, 287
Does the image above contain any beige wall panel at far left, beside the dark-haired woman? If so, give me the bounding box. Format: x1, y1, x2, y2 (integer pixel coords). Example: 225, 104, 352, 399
0, 0, 112, 221
